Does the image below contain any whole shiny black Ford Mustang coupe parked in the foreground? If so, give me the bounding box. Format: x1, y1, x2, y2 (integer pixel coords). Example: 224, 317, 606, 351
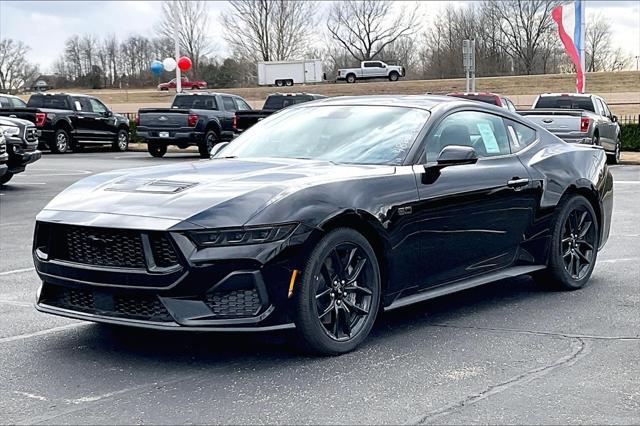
33, 96, 613, 353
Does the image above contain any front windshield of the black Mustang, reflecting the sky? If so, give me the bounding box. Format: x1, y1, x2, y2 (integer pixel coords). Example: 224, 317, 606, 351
219, 105, 429, 165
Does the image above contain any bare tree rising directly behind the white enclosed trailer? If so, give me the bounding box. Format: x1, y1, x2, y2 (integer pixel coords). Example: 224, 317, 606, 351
221, 0, 317, 61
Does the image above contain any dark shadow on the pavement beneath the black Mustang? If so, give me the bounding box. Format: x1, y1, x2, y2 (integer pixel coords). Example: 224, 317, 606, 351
40, 277, 554, 365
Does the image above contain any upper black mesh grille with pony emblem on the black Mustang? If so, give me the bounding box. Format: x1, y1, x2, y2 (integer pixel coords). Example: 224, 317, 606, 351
56, 226, 145, 269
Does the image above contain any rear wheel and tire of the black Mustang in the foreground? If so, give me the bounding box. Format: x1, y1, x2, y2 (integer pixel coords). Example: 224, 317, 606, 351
535, 195, 600, 290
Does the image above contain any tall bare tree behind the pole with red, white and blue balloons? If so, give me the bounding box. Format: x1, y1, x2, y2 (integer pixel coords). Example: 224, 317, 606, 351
160, 0, 211, 75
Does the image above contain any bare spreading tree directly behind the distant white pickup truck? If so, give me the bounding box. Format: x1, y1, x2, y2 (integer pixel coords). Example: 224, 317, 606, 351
327, 0, 419, 61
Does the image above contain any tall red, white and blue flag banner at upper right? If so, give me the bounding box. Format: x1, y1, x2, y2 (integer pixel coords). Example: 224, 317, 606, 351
551, 0, 586, 93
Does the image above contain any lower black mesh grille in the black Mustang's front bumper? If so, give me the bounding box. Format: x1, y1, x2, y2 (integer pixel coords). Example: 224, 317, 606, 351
41, 284, 173, 322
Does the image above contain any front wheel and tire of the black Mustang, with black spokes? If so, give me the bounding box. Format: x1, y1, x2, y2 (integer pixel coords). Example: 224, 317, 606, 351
295, 228, 382, 355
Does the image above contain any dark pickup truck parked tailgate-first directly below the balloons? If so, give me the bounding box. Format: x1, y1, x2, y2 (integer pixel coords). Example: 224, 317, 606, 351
136, 92, 250, 158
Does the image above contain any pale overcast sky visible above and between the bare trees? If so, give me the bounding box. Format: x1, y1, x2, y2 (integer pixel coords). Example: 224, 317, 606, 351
0, 0, 640, 72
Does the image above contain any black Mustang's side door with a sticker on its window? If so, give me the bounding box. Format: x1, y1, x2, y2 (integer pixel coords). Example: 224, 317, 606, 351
413, 110, 536, 287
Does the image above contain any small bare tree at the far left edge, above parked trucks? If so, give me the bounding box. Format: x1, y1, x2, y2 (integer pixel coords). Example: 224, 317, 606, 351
0, 38, 38, 92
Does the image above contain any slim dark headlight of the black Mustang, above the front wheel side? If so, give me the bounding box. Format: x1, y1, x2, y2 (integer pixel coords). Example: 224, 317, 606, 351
191, 223, 298, 247
